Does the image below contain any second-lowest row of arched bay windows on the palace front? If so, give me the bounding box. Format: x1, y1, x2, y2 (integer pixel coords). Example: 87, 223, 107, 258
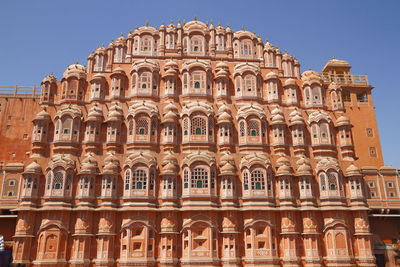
22, 163, 365, 199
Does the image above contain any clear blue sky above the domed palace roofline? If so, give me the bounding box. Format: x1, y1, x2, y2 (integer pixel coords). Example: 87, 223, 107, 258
0, 0, 400, 167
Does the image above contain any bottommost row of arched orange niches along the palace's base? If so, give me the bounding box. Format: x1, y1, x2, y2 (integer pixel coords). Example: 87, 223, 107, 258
14, 215, 372, 264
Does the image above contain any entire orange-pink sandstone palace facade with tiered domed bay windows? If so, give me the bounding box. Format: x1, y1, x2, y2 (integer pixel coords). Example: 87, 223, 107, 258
0, 20, 400, 267
